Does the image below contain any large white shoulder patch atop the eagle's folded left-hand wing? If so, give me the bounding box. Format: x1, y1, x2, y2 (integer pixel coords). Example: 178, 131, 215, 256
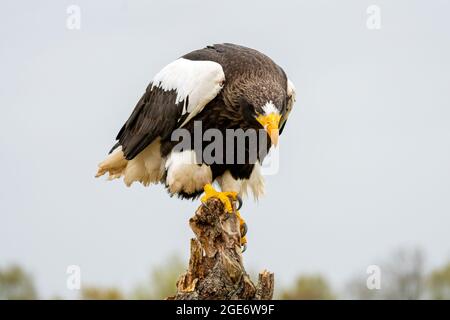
152, 58, 225, 127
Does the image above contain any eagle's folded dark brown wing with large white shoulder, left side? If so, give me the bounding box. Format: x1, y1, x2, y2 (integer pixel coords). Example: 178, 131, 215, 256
113, 58, 225, 160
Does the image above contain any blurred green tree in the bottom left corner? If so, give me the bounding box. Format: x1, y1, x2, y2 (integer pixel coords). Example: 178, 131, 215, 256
0, 265, 37, 300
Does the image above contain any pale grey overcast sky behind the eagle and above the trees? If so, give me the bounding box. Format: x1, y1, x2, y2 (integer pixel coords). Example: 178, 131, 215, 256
0, 0, 450, 297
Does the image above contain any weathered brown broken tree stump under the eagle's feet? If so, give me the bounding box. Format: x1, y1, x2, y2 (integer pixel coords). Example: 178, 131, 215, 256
168, 198, 274, 300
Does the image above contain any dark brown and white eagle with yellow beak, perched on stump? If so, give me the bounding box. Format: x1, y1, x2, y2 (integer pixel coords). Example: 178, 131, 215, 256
96, 43, 295, 250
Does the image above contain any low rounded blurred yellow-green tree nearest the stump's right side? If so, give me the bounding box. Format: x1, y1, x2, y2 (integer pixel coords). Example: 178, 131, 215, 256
280, 274, 335, 300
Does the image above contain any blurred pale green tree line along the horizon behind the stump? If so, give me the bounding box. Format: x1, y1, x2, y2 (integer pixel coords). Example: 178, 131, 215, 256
0, 249, 450, 300
